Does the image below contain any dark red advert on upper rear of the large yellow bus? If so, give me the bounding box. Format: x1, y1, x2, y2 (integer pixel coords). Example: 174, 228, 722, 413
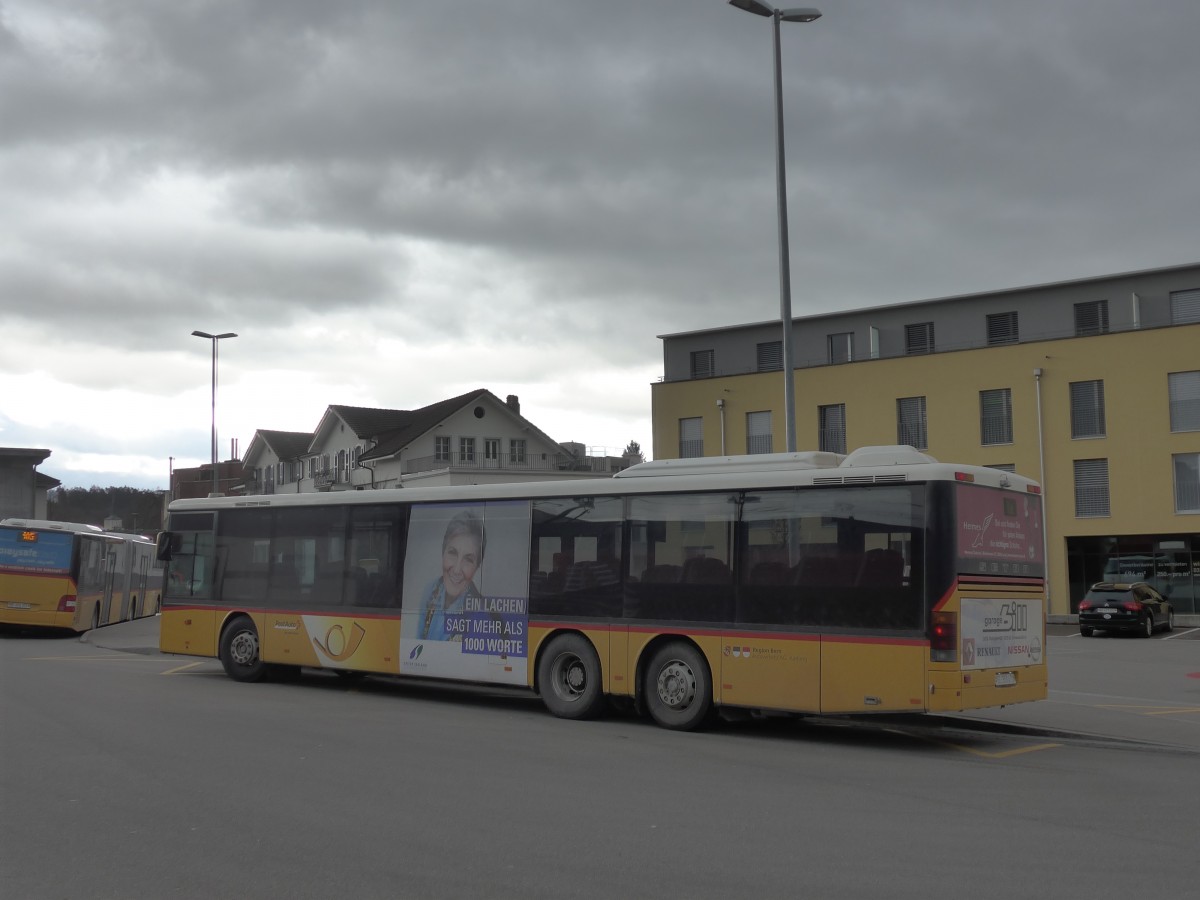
955, 485, 1045, 577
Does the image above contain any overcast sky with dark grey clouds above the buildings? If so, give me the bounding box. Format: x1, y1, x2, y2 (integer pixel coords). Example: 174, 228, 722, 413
0, 0, 1200, 488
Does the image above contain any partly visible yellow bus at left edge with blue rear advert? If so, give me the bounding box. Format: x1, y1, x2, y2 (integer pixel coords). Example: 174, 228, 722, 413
0, 518, 163, 631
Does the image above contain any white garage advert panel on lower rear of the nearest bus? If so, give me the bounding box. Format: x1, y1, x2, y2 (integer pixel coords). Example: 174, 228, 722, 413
961, 596, 1045, 670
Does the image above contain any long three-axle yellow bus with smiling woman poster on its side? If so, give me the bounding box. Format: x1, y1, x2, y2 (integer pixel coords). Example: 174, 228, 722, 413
160, 446, 1046, 730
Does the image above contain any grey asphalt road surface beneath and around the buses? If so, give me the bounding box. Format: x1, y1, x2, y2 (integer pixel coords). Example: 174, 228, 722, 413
0, 619, 1200, 900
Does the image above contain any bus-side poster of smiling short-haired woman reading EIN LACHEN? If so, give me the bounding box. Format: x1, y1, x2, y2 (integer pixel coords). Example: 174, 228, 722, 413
400, 500, 529, 684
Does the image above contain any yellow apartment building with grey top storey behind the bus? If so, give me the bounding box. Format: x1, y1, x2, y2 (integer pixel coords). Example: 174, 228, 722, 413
652, 263, 1200, 624
